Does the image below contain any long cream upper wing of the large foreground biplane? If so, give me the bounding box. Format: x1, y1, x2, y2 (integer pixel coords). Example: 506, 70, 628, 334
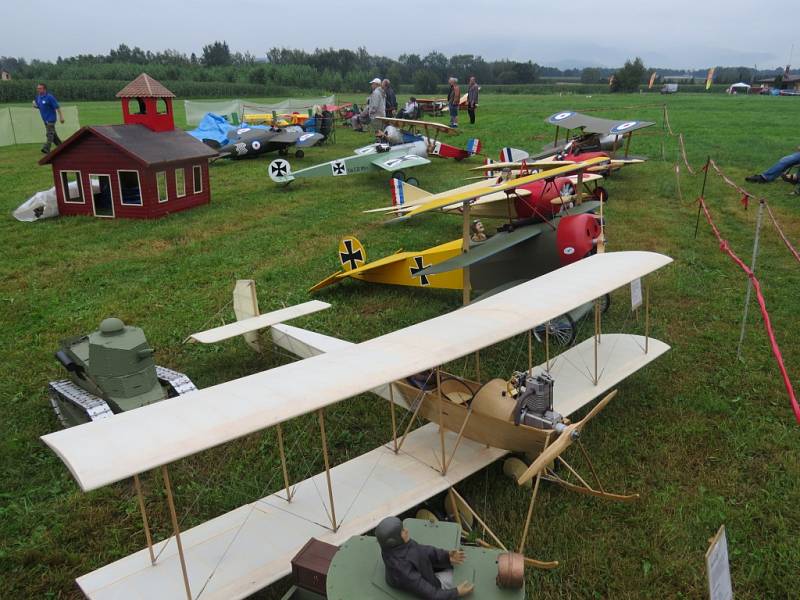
42, 252, 672, 491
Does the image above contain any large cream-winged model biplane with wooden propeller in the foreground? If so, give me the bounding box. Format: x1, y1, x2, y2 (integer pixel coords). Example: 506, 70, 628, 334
43, 252, 671, 600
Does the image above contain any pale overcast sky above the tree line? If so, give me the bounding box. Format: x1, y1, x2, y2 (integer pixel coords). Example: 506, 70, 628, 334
0, 0, 800, 68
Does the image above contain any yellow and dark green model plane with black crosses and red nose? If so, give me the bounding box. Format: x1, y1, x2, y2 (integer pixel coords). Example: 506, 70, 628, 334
311, 158, 607, 314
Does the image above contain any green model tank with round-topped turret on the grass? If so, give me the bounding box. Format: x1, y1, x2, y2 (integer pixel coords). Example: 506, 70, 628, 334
49, 317, 197, 427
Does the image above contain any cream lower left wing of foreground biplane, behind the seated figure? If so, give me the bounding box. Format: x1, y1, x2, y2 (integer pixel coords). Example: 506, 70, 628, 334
77, 423, 505, 600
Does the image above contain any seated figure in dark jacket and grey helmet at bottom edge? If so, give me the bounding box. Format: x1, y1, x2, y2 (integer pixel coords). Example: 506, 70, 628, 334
375, 517, 473, 600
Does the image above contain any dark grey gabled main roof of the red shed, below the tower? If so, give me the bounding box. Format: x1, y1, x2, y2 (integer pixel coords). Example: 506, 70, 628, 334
39, 125, 217, 167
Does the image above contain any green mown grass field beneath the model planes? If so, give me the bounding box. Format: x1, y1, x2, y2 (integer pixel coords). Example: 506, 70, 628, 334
0, 94, 800, 598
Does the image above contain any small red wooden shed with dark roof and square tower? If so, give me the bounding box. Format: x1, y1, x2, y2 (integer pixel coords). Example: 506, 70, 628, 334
39, 73, 217, 218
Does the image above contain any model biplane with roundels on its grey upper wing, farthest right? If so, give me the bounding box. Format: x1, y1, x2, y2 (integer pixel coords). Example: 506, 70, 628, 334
495, 111, 654, 173
